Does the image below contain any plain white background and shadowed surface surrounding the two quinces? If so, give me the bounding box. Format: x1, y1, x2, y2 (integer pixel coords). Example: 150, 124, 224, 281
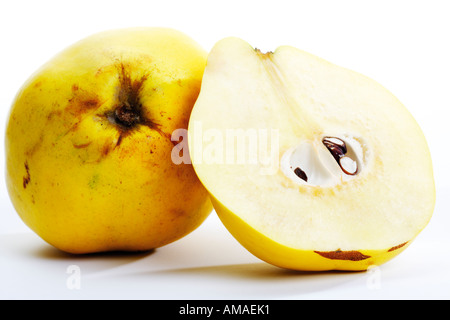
0, 0, 450, 299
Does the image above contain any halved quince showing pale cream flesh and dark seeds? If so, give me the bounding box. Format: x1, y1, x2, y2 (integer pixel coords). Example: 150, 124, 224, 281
189, 37, 435, 271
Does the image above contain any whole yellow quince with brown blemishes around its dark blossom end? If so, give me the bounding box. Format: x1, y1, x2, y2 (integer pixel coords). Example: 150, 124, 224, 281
5, 28, 212, 254
